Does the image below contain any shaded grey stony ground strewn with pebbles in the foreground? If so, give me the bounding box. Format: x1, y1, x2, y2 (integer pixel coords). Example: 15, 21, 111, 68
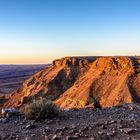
0, 104, 140, 140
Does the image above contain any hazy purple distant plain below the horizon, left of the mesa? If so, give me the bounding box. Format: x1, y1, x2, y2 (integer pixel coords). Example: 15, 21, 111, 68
0, 65, 47, 94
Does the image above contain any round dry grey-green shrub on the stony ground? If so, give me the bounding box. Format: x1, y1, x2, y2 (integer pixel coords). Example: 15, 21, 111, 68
24, 98, 59, 120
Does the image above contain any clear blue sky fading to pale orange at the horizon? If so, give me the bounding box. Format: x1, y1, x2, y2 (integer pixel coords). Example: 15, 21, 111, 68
0, 0, 140, 64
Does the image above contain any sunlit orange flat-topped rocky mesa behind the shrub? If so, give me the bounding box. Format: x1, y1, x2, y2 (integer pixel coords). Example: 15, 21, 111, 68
3, 57, 140, 109
